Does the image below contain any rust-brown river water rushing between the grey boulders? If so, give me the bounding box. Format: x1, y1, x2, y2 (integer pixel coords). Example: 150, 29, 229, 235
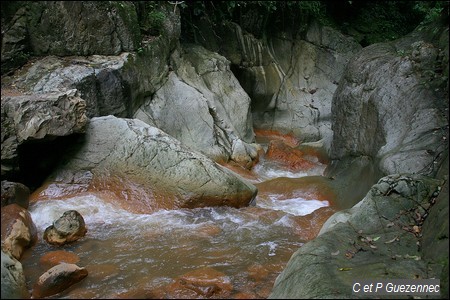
21, 132, 335, 299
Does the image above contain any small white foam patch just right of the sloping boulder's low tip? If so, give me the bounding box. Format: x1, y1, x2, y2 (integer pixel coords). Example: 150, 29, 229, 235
256, 195, 330, 216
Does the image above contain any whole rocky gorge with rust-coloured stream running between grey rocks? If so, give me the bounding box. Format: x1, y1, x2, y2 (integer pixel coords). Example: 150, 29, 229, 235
1, 1, 448, 299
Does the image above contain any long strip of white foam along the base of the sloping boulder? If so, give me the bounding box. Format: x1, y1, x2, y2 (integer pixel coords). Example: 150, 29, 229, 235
29, 195, 283, 239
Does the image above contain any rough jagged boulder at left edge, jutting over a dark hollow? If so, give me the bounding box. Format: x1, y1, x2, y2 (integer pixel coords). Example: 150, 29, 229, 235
1, 90, 87, 176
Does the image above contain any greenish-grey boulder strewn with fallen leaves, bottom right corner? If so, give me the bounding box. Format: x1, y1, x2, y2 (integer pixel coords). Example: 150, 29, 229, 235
269, 174, 443, 299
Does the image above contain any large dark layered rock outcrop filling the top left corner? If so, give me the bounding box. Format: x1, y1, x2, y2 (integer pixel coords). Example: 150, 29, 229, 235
2, 1, 180, 117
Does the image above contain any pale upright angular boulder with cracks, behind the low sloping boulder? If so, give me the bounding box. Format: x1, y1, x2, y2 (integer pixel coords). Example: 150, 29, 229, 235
134, 45, 257, 167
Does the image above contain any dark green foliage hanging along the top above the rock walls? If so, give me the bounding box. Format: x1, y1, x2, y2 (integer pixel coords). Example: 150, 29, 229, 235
180, 0, 440, 46
